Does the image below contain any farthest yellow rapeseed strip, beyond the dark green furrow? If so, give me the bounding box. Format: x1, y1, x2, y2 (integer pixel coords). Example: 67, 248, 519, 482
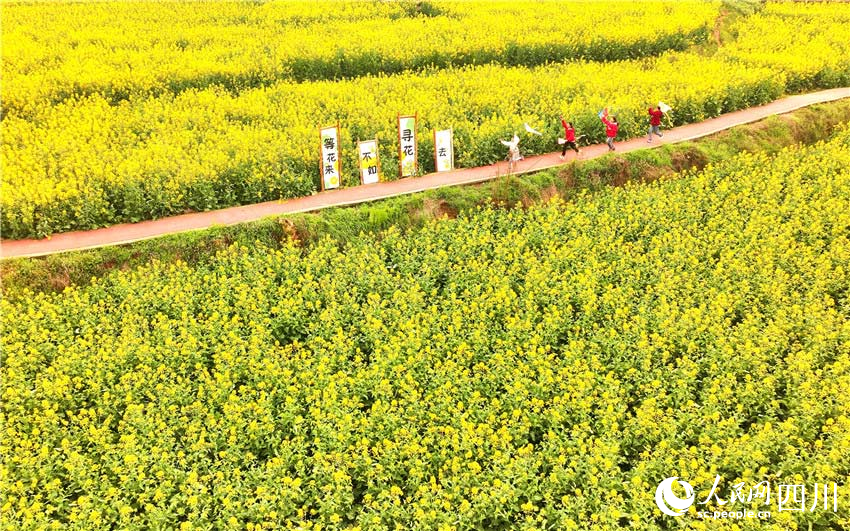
2, 0, 718, 115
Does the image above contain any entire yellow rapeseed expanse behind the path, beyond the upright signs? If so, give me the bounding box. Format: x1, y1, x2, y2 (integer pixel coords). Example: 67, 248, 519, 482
0, 1, 850, 238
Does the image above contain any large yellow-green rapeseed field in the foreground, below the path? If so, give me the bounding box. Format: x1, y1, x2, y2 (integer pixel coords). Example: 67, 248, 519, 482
0, 130, 850, 530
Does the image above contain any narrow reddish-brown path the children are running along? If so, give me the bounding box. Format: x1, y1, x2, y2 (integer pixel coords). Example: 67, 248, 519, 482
0, 88, 850, 258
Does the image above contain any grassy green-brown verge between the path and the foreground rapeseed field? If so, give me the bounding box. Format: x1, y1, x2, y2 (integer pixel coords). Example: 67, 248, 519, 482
0, 99, 850, 299
